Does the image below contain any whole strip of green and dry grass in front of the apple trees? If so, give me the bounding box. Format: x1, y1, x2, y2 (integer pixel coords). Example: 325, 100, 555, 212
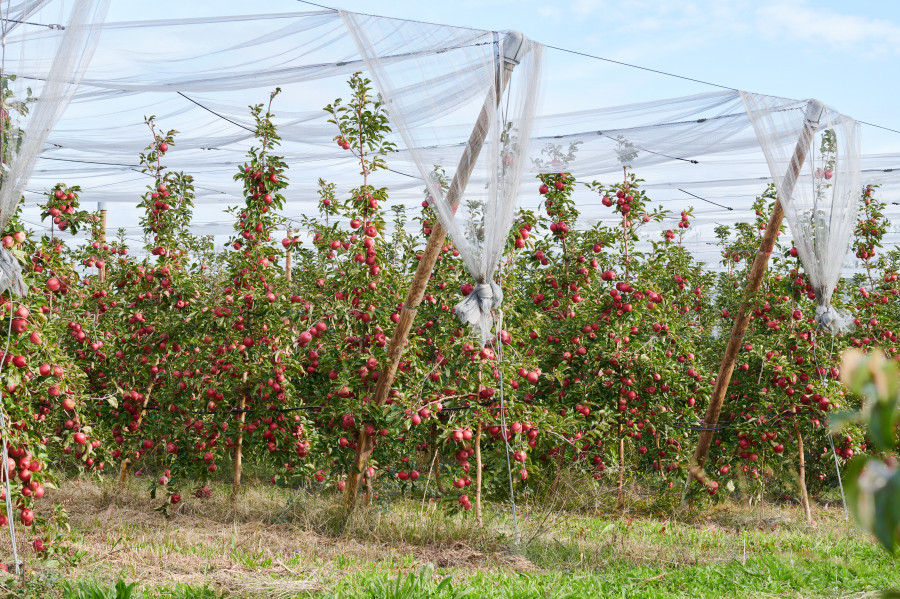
0, 482, 900, 599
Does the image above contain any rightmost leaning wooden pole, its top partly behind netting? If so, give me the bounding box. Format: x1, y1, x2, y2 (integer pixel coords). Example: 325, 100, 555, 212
688, 100, 825, 480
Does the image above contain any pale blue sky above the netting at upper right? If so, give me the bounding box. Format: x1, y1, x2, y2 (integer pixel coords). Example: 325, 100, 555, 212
278, 0, 900, 153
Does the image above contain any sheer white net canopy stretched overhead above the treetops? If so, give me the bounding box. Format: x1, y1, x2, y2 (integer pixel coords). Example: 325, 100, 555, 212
0, 2, 884, 279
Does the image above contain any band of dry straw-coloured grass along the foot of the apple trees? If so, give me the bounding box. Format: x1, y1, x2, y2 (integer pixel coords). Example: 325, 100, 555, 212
14, 478, 876, 597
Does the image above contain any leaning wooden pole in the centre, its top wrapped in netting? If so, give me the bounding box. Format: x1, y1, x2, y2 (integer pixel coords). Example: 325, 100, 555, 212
344, 32, 524, 510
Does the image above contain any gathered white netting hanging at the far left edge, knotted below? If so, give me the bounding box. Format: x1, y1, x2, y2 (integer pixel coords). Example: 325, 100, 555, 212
0, 0, 109, 295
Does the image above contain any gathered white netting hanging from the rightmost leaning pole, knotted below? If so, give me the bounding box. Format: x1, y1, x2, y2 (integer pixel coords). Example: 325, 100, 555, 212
742, 93, 860, 332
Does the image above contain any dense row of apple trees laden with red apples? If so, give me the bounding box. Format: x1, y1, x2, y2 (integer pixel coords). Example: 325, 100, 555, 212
0, 75, 888, 552
